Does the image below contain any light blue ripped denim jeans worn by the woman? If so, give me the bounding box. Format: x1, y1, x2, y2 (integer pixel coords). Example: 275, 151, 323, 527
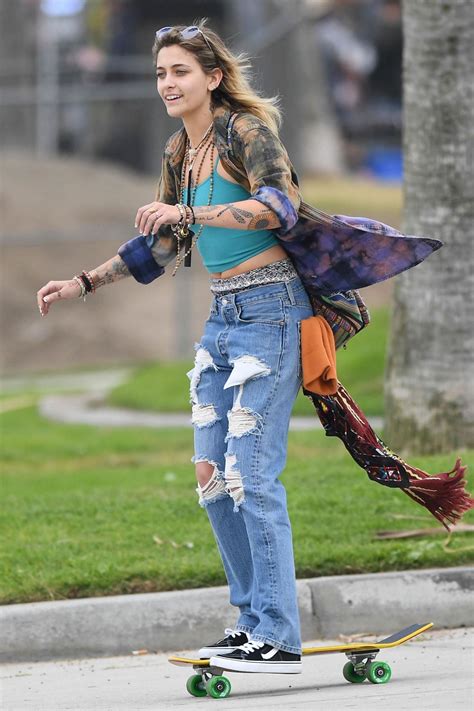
188, 277, 313, 654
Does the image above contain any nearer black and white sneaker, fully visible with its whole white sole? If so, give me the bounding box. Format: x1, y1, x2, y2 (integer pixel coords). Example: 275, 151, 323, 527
209, 640, 303, 674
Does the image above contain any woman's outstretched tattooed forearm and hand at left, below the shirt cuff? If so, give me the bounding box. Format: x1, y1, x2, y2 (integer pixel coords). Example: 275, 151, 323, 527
36, 254, 130, 316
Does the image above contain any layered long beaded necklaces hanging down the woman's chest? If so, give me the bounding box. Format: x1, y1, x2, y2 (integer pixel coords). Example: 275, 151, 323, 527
171, 123, 215, 276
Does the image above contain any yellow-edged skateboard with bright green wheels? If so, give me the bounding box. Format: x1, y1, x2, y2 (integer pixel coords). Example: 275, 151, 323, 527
168, 622, 433, 699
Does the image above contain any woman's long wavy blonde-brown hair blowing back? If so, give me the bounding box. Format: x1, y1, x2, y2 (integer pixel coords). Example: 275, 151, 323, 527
152, 18, 281, 135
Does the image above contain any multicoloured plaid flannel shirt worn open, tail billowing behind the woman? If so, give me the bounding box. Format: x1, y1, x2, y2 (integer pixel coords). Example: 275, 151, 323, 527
119, 107, 442, 295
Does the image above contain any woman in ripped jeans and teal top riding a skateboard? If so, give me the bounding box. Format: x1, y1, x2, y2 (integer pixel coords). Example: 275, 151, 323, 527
37, 15, 470, 674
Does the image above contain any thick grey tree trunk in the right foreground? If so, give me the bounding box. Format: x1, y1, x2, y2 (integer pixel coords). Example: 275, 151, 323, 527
386, 0, 474, 453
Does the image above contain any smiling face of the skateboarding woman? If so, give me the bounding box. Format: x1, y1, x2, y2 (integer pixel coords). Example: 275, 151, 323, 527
156, 44, 220, 118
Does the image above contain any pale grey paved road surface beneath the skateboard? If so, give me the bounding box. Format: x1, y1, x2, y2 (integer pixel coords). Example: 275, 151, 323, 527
0, 628, 474, 711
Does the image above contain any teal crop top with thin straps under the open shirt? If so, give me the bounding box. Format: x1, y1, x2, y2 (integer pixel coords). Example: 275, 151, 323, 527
184, 161, 278, 273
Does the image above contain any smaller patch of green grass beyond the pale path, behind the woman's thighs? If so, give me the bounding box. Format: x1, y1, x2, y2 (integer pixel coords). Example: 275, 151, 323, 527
108, 308, 389, 417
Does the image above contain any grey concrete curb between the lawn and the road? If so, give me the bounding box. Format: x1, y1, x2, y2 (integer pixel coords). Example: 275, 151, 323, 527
0, 567, 474, 662
